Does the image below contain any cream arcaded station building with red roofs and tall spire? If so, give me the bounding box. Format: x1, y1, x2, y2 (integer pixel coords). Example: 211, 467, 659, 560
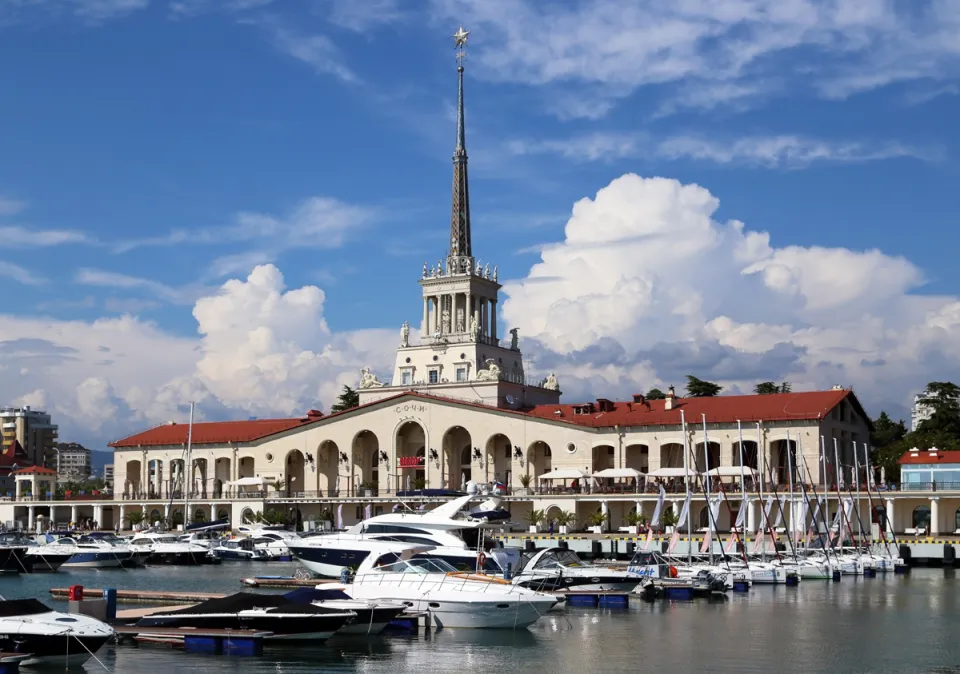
0, 40, 960, 532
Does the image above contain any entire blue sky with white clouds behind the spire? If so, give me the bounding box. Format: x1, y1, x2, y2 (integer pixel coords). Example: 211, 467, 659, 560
0, 0, 960, 443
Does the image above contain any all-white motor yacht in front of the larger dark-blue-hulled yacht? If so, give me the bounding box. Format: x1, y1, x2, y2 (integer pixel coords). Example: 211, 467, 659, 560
328, 543, 559, 629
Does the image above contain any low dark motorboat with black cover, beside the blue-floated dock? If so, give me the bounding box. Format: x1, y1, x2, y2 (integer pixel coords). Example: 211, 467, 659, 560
136, 592, 357, 643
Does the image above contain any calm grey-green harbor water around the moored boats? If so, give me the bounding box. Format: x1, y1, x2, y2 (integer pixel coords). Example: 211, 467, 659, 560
0, 563, 960, 674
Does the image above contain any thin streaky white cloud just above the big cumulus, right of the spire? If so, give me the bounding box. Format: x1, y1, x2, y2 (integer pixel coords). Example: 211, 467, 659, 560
505, 131, 943, 168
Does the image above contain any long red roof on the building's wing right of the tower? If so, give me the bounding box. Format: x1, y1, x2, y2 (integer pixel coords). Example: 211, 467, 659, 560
527, 389, 870, 428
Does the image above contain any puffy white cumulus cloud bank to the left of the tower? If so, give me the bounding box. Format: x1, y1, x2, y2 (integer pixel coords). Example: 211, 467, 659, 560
0, 265, 396, 448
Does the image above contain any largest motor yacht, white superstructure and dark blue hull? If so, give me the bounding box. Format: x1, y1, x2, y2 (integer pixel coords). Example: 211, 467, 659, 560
286, 495, 519, 578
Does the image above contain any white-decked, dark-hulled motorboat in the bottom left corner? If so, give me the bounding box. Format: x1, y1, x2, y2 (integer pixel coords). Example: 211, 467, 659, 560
0, 599, 114, 667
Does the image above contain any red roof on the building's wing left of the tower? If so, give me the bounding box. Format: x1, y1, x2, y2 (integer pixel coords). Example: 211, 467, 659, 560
110, 416, 312, 448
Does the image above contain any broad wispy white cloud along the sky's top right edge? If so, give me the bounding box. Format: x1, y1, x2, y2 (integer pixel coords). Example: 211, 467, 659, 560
433, 0, 960, 117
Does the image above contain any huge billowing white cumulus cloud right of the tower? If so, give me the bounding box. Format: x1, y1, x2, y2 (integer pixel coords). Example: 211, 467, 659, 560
503, 174, 960, 410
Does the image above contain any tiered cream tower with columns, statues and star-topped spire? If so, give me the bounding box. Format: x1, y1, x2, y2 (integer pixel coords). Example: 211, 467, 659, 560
360, 28, 560, 408
